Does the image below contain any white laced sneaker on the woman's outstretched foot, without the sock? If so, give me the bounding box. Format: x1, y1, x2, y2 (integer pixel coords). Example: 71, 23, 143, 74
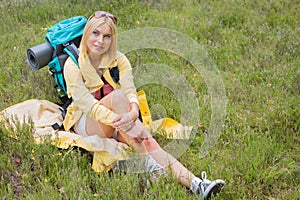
196, 171, 225, 199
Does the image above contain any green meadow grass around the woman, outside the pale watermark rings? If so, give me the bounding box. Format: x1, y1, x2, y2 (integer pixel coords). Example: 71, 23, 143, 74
0, 0, 300, 199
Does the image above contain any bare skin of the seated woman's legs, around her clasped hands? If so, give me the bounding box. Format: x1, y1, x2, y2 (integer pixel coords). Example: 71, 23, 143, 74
86, 90, 195, 187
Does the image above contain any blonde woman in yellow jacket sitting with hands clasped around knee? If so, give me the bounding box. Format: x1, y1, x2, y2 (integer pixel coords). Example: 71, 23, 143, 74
64, 11, 225, 198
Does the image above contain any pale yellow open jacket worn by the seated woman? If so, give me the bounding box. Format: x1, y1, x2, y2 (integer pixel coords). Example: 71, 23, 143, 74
63, 52, 138, 131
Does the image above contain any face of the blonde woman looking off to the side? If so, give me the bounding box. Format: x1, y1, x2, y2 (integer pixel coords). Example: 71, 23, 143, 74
87, 23, 112, 56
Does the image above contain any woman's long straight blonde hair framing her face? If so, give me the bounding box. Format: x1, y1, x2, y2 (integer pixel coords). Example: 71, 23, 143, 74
79, 16, 117, 66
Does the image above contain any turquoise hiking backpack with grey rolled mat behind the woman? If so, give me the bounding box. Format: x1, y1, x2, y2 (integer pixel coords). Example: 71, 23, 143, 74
26, 16, 87, 104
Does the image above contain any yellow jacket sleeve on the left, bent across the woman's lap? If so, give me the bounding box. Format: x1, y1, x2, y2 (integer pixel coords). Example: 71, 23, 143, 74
64, 59, 117, 125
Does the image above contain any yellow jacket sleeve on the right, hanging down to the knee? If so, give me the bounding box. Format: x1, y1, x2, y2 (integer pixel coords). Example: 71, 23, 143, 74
118, 54, 139, 105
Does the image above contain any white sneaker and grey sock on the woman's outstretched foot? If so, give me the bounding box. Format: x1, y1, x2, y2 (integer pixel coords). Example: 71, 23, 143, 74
191, 171, 225, 199
